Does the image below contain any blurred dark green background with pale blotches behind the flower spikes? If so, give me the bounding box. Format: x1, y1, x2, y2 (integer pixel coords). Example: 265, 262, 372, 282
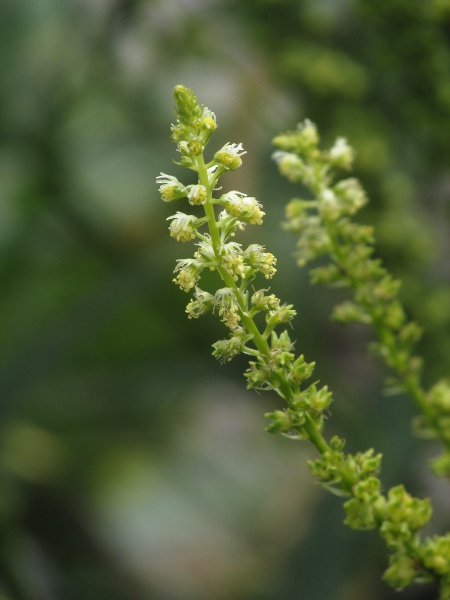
0, 0, 450, 600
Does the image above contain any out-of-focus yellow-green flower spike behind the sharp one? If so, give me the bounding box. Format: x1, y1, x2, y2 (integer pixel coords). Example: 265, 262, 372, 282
274, 121, 450, 476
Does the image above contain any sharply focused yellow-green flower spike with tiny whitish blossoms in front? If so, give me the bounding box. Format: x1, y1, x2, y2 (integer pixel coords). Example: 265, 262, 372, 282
158, 85, 450, 600
